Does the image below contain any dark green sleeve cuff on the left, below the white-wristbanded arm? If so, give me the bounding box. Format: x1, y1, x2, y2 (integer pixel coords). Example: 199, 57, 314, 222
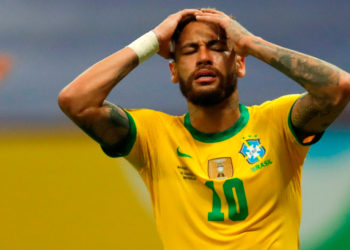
101, 110, 137, 157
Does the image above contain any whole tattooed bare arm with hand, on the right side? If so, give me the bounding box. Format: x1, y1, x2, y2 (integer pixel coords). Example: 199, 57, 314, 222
195, 9, 350, 141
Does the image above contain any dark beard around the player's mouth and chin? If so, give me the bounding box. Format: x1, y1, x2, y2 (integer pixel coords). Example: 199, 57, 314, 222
179, 66, 237, 107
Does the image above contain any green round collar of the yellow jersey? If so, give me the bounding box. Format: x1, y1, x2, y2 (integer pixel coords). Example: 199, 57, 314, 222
184, 104, 249, 143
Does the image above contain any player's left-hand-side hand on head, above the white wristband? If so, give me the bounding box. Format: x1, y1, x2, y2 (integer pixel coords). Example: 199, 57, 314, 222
153, 9, 200, 59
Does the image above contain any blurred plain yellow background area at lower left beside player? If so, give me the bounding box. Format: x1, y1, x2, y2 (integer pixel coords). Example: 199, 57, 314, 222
0, 129, 161, 250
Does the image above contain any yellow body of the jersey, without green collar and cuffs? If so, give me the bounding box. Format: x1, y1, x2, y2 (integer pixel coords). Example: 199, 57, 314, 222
121, 95, 309, 250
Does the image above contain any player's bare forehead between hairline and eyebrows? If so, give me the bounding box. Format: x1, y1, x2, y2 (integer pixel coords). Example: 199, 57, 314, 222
178, 22, 220, 44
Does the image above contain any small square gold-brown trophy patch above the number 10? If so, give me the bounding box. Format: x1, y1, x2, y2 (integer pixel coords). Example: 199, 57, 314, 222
208, 157, 233, 180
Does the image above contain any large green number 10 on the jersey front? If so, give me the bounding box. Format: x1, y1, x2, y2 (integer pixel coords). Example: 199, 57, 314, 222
205, 178, 248, 221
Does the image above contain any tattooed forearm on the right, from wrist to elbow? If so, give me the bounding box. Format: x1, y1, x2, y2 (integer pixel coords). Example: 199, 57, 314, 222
248, 37, 347, 98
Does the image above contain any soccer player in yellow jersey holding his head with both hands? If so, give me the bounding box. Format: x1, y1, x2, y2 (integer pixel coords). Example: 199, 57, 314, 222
59, 9, 350, 249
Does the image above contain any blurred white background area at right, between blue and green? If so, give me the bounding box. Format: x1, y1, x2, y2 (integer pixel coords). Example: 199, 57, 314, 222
300, 150, 350, 245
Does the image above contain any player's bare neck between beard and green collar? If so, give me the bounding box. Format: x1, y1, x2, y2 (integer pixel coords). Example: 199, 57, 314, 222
188, 90, 241, 133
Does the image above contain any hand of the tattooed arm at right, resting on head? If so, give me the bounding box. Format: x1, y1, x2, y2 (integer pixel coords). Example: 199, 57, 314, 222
195, 9, 253, 57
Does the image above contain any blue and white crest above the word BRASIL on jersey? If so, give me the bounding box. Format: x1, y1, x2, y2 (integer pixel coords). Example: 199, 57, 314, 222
239, 139, 266, 164
